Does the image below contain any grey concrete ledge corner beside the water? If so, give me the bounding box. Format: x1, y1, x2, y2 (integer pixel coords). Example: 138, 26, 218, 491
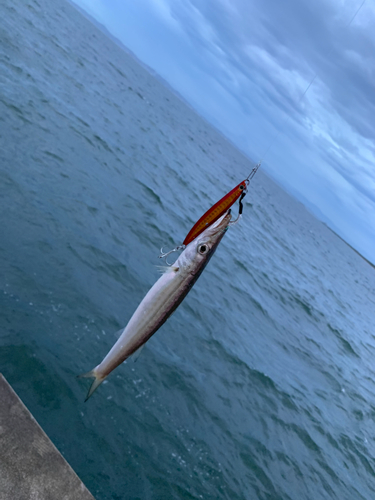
0, 374, 94, 500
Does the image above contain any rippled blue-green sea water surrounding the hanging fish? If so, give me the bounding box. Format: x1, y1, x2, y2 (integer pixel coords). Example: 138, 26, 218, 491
0, 0, 375, 500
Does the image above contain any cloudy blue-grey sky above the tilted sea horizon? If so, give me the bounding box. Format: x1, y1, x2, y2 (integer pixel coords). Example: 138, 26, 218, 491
74, 0, 375, 263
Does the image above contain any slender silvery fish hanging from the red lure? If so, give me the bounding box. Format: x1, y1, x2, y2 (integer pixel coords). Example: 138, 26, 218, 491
80, 210, 231, 401
